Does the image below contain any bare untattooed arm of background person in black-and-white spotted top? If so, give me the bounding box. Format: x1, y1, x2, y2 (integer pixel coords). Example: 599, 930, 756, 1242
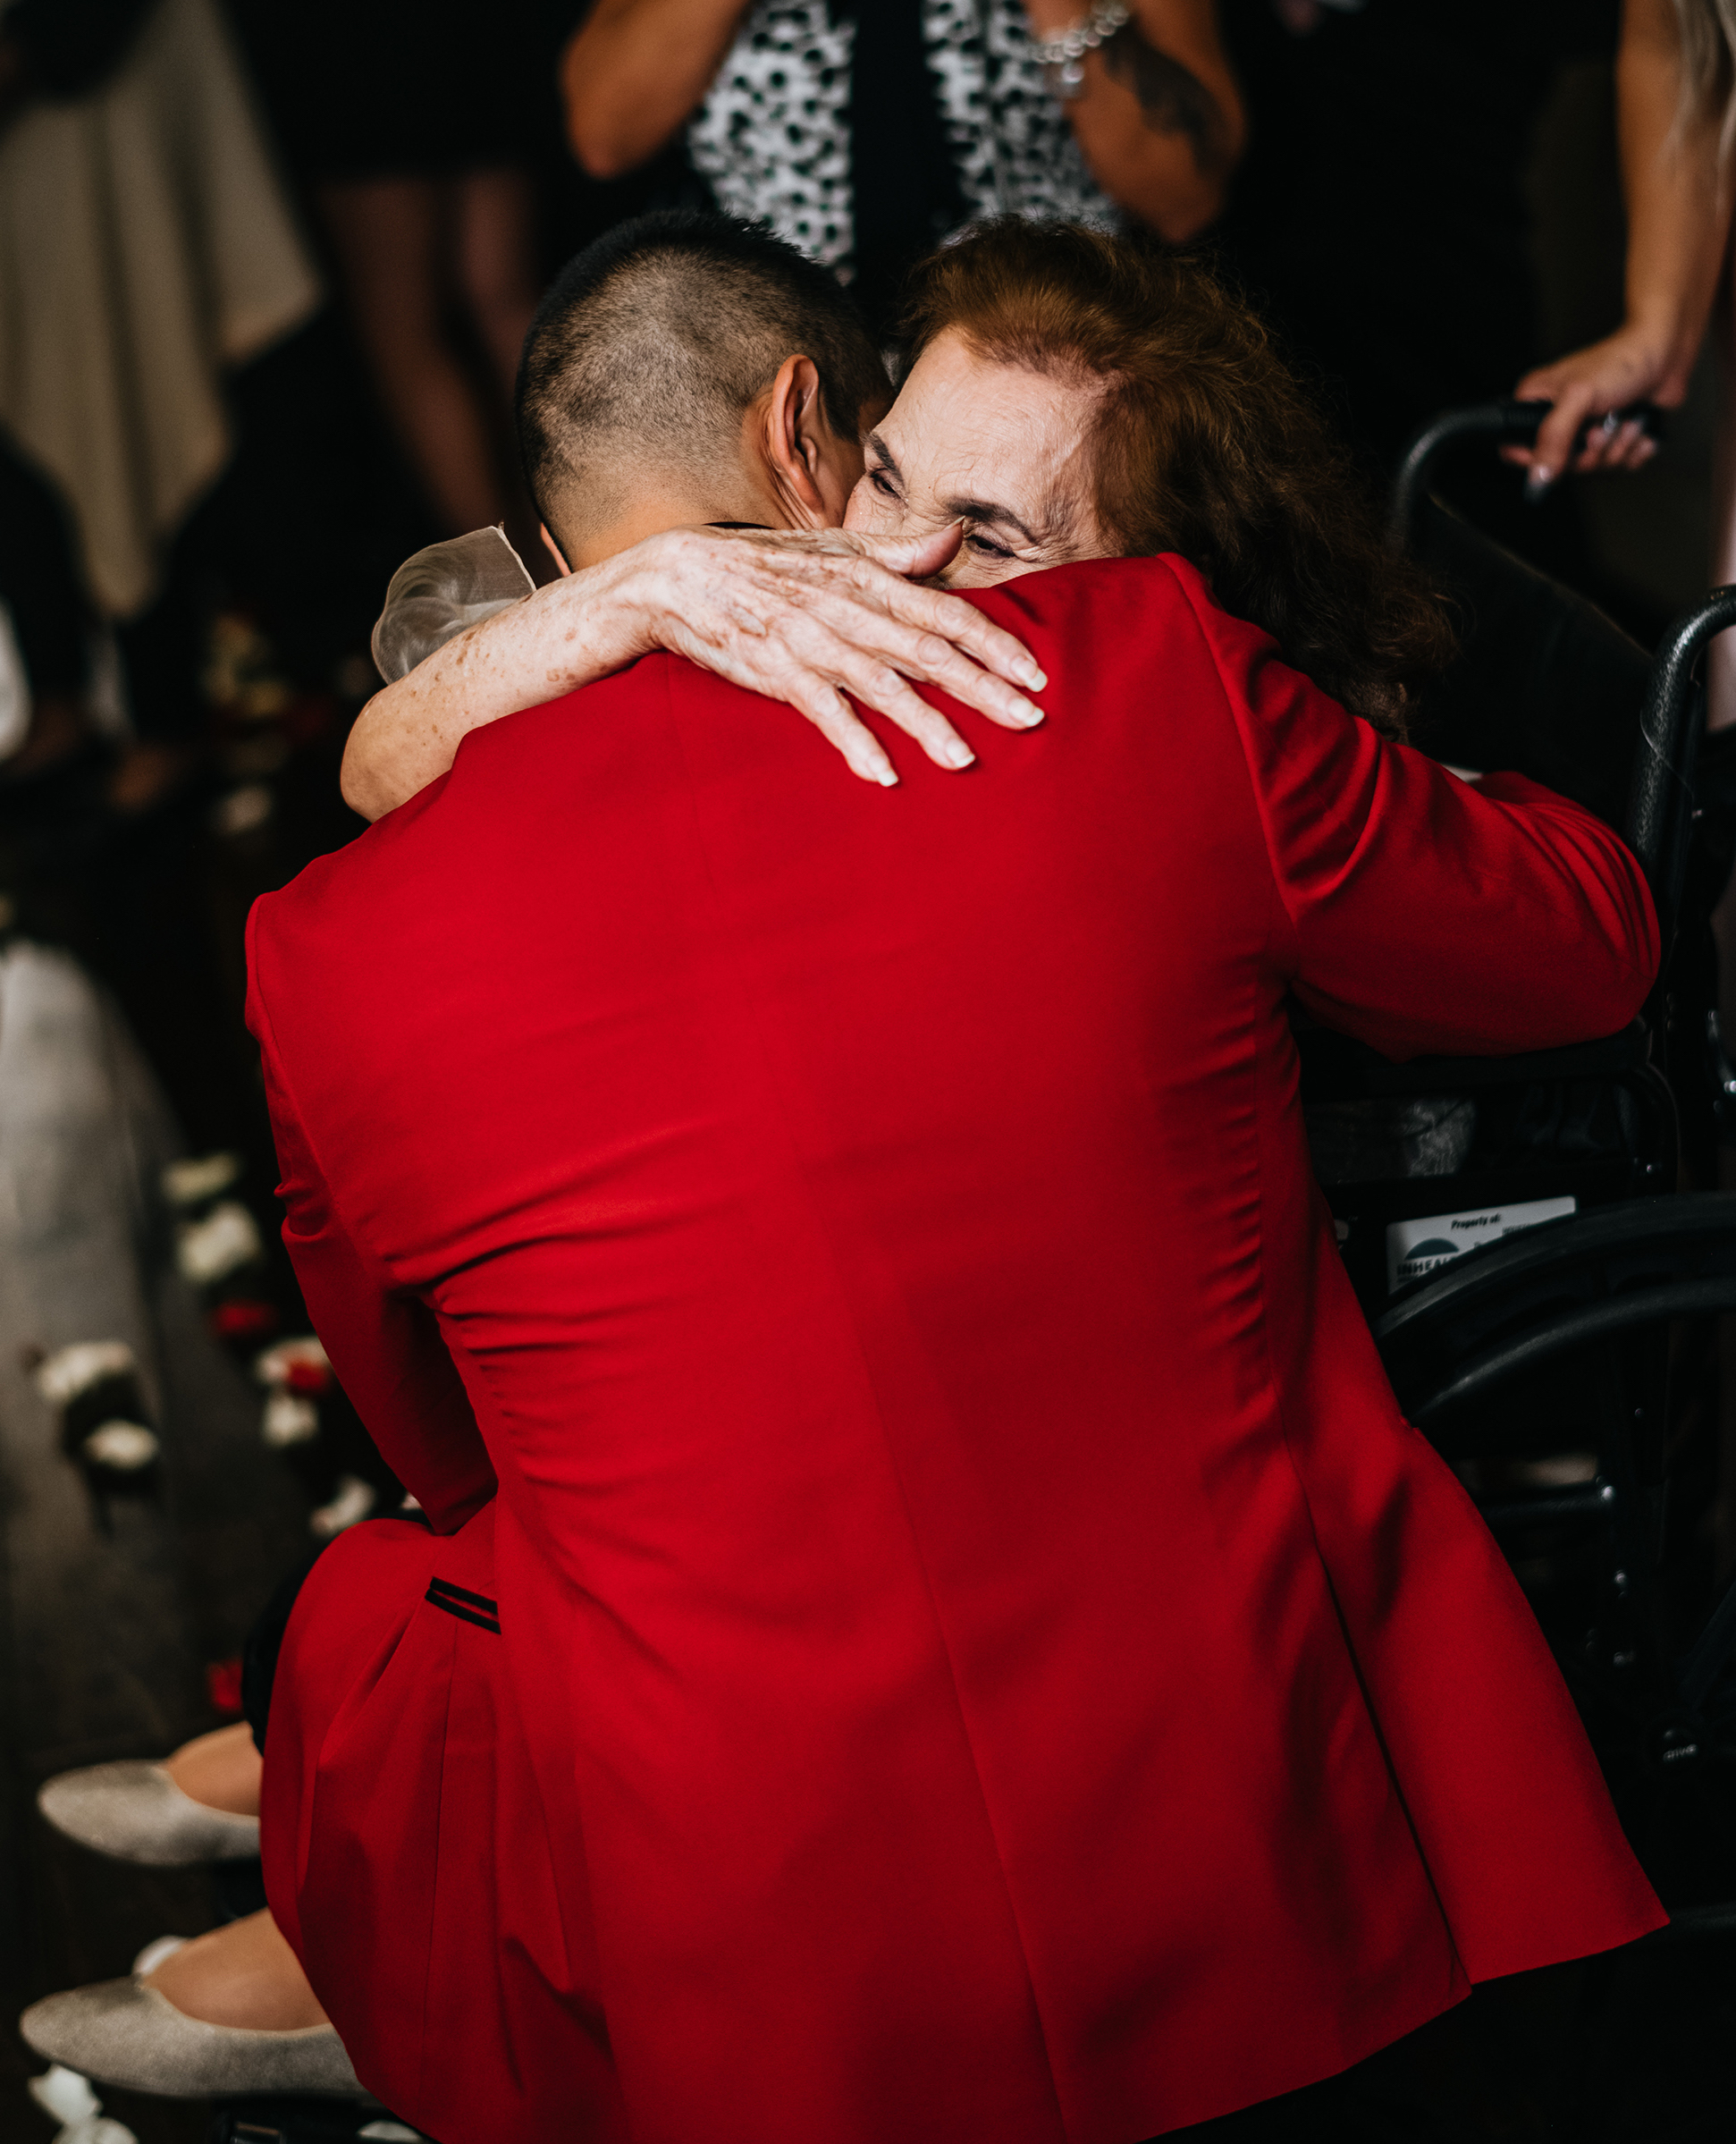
561, 0, 750, 178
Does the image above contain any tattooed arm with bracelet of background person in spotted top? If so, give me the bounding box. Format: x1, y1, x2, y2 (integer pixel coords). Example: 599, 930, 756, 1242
1024, 0, 1247, 244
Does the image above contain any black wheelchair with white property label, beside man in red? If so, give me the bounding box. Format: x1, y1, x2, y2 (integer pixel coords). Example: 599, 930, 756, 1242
1299, 403, 1736, 1963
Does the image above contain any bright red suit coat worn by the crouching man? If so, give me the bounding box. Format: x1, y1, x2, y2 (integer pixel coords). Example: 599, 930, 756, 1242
251, 560, 1661, 2144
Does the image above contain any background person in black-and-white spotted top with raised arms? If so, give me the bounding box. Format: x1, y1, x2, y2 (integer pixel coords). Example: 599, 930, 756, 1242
561, 0, 1243, 333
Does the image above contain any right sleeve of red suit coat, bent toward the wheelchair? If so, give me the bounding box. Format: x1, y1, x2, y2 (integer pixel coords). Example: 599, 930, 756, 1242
1190, 566, 1659, 1059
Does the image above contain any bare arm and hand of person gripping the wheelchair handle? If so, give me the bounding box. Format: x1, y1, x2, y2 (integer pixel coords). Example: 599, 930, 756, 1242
1504, 0, 1730, 486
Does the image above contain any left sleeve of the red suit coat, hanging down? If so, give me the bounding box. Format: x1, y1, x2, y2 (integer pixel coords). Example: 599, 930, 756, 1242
247, 907, 495, 1533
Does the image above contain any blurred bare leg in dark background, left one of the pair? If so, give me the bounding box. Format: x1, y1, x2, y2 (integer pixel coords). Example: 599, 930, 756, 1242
319, 178, 506, 536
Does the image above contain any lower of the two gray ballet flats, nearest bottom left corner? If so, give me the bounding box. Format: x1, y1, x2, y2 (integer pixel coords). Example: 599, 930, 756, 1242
17, 1979, 367, 2099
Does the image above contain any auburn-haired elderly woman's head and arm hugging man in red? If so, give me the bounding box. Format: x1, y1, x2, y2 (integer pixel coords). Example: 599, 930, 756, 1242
343, 219, 1451, 819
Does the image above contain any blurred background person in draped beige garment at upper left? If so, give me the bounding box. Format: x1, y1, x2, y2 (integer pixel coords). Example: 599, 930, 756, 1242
0, 0, 322, 810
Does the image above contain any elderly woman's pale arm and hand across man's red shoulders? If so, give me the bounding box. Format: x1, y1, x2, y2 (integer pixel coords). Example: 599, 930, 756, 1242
343, 528, 1048, 819
